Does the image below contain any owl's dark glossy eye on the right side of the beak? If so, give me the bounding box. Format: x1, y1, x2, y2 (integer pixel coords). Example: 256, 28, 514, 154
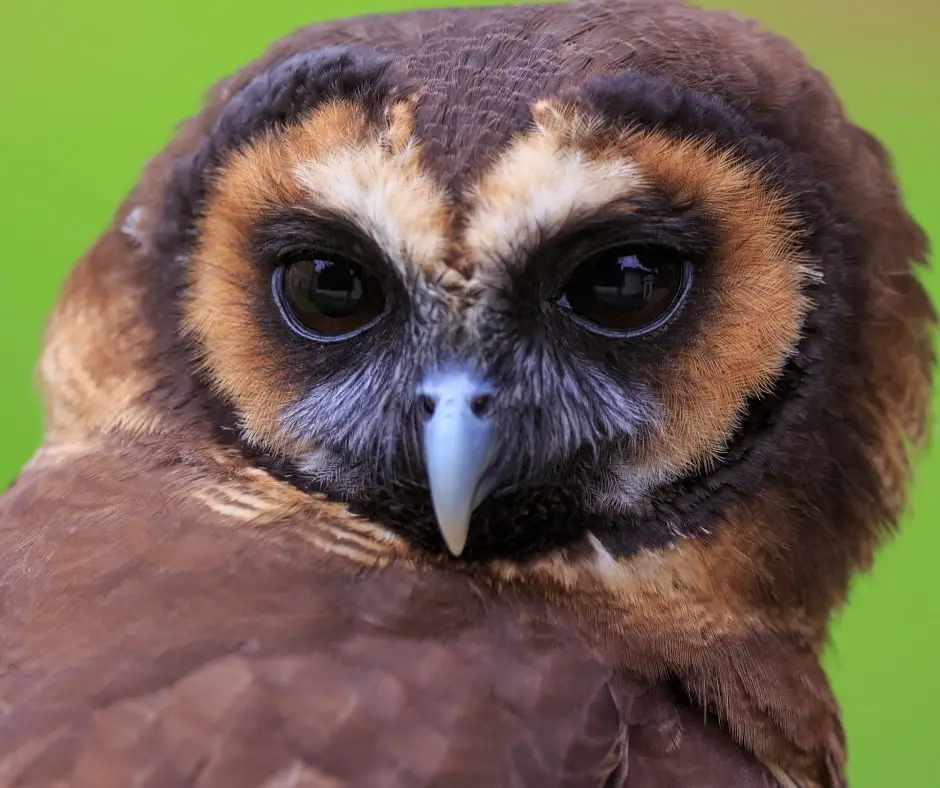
558, 246, 691, 336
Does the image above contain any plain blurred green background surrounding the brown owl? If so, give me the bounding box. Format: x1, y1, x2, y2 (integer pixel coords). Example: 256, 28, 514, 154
0, 0, 940, 788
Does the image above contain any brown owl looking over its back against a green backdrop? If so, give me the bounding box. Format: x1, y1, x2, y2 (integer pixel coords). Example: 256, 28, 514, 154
0, 0, 934, 788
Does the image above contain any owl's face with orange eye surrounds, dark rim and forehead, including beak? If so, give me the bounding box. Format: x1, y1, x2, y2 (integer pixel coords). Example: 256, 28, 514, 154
129, 10, 928, 560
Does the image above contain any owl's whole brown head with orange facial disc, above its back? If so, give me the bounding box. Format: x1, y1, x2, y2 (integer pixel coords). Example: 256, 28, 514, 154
41, 0, 933, 627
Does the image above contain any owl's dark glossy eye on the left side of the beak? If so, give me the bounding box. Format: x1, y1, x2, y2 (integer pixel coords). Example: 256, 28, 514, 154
272, 254, 385, 341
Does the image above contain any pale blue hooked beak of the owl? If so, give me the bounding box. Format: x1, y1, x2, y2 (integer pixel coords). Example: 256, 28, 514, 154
418, 370, 495, 556
